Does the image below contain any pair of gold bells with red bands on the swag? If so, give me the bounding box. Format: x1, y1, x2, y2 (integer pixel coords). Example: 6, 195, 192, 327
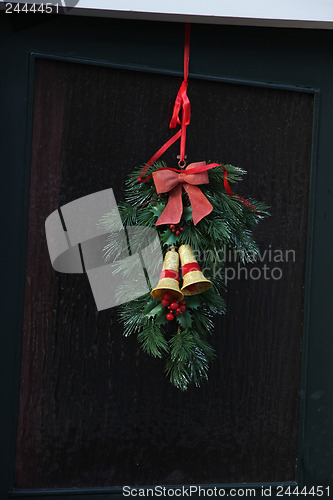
151, 245, 212, 301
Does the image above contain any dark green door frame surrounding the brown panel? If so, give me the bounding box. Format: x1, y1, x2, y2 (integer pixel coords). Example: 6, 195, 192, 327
0, 12, 333, 499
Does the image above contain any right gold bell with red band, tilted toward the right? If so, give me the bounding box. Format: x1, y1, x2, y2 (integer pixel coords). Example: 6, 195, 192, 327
178, 245, 212, 295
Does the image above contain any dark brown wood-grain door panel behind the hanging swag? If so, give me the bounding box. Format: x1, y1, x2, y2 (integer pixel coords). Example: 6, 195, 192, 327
16, 60, 313, 488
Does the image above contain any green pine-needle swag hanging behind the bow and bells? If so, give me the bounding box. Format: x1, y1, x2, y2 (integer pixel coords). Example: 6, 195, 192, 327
101, 161, 268, 390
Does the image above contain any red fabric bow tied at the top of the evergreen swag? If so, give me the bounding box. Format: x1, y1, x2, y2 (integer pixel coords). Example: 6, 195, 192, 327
153, 161, 213, 226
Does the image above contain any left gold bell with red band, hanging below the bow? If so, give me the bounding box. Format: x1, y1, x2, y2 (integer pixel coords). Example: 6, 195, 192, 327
151, 248, 184, 301
